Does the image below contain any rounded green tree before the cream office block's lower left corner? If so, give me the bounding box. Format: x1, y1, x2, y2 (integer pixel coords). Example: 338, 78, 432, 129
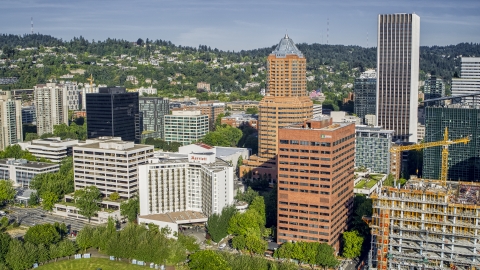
74, 186, 102, 222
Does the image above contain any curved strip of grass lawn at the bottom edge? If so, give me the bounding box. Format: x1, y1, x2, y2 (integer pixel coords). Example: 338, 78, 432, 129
37, 258, 150, 270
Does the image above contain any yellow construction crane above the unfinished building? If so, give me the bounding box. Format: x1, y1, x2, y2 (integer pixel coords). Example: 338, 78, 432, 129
390, 127, 470, 186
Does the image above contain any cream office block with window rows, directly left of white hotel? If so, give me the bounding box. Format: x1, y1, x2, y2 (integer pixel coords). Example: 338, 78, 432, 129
73, 137, 153, 199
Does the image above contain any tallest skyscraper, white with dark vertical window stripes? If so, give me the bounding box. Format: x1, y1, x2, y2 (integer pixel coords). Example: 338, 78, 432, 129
376, 13, 420, 143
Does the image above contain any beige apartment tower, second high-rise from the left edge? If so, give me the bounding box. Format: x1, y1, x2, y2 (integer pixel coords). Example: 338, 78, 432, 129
34, 83, 68, 136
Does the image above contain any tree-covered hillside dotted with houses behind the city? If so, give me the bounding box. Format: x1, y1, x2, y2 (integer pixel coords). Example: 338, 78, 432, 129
0, 34, 480, 103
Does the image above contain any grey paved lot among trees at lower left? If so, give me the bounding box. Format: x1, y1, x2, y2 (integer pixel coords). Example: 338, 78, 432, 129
4, 207, 95, 231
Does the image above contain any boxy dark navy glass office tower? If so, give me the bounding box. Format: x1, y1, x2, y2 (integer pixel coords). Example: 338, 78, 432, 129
86, 87, 142, 143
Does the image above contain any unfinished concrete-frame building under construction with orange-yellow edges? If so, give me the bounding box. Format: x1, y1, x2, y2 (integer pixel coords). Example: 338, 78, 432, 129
368, 179, 480, 270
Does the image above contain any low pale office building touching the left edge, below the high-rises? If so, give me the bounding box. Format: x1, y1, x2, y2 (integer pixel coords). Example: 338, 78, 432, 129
0, 158, 60, 188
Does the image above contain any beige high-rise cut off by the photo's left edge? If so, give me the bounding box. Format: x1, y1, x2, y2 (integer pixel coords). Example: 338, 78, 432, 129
0, 91, 23, 151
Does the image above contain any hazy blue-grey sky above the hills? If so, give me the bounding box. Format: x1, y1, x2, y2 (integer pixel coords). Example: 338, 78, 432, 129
0, 0, 480, 51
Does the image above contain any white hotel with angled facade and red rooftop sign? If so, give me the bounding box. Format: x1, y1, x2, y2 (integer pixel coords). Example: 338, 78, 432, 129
139, 153, 234, 217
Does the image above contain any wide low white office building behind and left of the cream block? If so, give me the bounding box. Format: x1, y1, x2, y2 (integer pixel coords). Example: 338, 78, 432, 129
19, 137, 79, 163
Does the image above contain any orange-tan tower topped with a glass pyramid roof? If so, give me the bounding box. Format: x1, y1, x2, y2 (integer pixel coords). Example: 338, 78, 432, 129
258, 35, 313, 158
